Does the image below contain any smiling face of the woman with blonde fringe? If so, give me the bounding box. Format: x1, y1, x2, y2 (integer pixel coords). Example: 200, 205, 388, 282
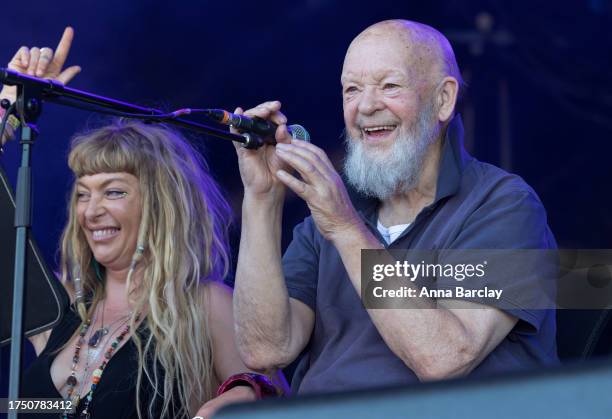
76, 172, 142, 270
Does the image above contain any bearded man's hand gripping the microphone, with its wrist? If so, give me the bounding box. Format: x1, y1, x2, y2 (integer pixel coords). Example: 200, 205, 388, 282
232, 101, 291, 197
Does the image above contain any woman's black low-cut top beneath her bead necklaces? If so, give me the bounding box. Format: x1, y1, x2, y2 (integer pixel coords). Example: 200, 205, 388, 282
21, 307, 173, 419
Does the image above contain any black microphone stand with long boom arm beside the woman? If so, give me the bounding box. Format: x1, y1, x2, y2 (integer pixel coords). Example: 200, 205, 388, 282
0, 68, 256, 419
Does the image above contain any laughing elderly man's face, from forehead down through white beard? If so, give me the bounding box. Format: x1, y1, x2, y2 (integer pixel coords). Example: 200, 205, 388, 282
342, 32, 440, 200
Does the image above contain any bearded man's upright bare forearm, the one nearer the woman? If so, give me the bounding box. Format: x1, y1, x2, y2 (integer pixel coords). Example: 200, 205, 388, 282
234, 192, 290, 369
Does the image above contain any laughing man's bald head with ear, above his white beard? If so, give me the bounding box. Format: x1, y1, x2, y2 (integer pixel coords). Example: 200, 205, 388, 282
341, 20, 461, 175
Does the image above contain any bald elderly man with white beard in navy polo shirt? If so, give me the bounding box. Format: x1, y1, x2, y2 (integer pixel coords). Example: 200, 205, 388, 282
234, 20, 557, 393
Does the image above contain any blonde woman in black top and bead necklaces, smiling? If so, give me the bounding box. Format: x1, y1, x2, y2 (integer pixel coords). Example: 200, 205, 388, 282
0, 29, 284, 418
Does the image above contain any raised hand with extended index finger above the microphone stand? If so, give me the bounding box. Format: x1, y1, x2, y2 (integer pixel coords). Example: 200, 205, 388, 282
0, 27, 81, 102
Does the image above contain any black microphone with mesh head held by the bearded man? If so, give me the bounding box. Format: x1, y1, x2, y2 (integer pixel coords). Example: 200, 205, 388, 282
175, 109, 310, 145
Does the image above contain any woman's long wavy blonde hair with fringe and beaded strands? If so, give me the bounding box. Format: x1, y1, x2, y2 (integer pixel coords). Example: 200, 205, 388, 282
61, 119, 231, 417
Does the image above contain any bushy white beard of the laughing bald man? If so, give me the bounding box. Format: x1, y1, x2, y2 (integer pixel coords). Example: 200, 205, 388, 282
344, 104, 440, 201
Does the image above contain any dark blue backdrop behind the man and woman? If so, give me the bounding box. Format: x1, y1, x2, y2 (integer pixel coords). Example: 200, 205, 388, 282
0, 0, 612, 400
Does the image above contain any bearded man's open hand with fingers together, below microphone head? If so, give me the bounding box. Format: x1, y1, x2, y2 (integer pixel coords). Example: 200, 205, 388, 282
276, 140, 361, 241
